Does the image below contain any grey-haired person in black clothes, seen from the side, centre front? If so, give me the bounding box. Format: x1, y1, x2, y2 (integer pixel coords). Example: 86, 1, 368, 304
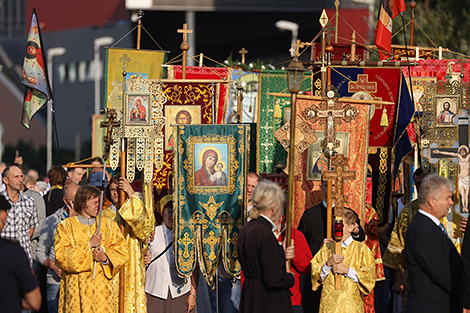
238, 181, 295, 313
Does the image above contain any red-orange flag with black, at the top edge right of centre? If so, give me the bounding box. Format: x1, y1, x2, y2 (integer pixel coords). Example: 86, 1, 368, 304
375, 0, 406, 60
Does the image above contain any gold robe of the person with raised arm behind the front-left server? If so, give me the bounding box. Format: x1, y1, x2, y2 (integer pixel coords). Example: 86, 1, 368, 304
114, 194, 155, 313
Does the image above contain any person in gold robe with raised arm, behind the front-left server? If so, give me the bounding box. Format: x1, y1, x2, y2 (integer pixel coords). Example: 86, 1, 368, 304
103, 176, 155, 313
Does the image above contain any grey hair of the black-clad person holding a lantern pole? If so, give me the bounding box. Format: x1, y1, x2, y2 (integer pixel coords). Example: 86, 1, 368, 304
250, 180, 284, 219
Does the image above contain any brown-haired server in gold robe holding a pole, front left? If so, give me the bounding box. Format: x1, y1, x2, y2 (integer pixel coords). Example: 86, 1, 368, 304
55, 186, 129, 313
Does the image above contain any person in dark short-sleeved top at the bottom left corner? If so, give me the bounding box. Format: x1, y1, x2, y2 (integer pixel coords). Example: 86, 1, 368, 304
0, 195, 41, 312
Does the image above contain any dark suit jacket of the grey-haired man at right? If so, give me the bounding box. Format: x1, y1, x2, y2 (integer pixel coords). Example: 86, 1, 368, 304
405, 213, 462, 313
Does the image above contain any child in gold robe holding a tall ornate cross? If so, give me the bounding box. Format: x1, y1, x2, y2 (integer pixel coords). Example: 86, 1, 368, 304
311, 209, 376, 313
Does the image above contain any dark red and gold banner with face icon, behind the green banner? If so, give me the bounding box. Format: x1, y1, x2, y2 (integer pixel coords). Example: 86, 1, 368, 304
153, 82, 218, 196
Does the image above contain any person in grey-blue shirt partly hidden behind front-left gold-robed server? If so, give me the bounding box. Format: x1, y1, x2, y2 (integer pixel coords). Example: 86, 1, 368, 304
36, 184, 80, 313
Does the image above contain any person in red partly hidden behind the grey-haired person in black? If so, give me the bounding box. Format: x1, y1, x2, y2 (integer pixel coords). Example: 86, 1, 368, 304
274, 207, 313, 313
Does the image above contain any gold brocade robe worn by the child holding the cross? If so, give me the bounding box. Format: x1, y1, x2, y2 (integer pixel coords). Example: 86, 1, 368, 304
311, 240, 376, 313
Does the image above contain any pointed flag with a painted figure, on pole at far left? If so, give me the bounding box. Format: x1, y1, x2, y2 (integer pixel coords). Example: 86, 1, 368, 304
21, 9, 52, 129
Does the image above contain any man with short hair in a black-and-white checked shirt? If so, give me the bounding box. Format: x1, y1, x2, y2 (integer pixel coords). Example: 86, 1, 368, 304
0, 163, 39, 266
